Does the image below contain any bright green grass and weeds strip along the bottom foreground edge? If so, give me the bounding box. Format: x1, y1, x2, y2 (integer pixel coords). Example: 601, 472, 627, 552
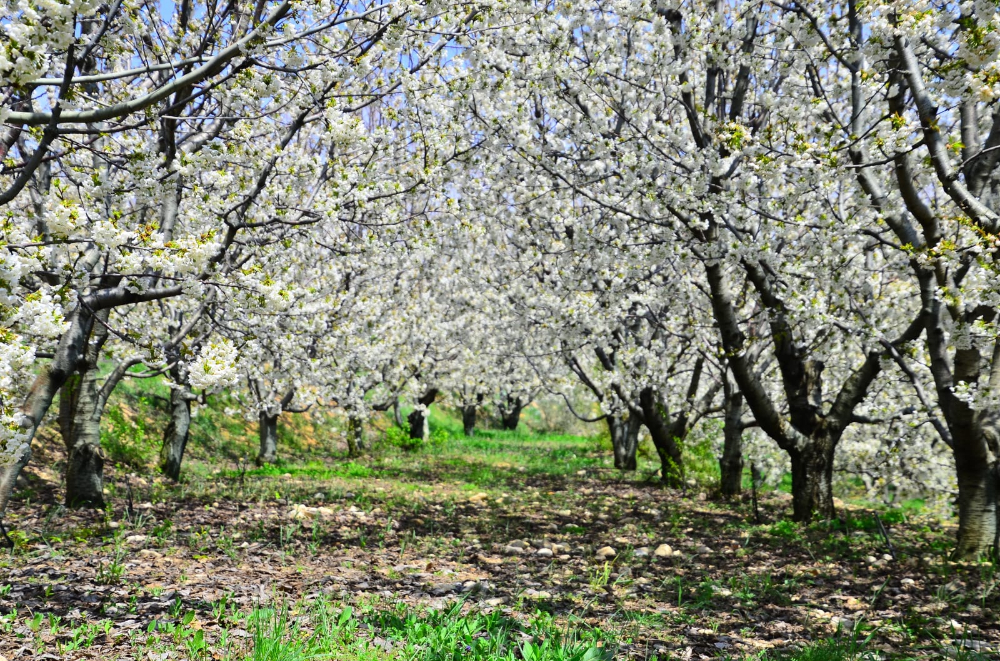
0, 596, 615, 661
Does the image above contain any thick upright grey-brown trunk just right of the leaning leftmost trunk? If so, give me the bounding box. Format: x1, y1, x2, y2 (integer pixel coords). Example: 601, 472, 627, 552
59, 362, 104, 509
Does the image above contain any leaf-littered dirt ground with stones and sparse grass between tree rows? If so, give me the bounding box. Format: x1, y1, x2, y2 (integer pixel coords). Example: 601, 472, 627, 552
0, 434, 1000, 660
